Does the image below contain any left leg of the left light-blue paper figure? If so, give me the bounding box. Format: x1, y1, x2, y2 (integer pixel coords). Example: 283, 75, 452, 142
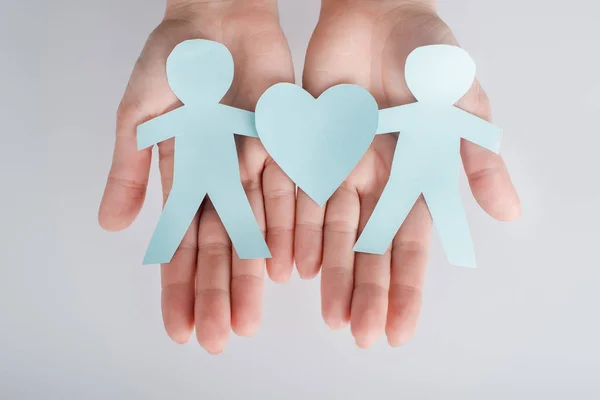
144, 181, 205, 264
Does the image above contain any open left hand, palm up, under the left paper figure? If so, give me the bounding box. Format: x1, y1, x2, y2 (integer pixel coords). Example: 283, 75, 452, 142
99, 0, 295, 353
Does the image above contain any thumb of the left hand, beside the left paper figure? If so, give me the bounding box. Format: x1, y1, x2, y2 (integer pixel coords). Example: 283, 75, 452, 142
98, 22, 185, 230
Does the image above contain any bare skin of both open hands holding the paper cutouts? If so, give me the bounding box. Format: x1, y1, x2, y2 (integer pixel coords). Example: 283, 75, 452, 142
99, 0, 520, 354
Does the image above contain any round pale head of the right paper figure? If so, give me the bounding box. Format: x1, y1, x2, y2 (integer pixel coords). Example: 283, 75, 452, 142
405, 45, 475, 105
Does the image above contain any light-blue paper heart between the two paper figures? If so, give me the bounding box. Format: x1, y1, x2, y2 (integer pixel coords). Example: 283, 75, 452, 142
256, 83, 378, 206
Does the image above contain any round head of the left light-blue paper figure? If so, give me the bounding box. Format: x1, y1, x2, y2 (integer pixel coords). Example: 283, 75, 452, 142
167, 39, 233, 104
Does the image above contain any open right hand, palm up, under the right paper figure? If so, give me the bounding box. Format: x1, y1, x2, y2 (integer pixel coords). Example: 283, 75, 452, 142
295, 0, 520, 347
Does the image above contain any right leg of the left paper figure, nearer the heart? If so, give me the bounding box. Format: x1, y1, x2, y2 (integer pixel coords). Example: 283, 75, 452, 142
208, 182, 271, 259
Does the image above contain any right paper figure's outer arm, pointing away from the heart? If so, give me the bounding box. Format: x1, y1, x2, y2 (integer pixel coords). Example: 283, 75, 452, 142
450, 107, 502, 154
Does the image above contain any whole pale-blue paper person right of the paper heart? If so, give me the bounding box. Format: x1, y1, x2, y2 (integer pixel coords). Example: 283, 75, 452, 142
354, 45, 502, 267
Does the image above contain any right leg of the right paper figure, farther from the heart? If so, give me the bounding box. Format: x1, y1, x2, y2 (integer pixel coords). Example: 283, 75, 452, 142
424, 186, 477, 268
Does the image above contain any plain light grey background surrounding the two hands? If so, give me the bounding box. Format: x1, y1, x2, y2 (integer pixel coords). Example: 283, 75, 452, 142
0, 0, 600, 400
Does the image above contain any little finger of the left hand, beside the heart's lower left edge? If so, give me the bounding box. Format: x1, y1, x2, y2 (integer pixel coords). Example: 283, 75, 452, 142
262, 158, 296, 283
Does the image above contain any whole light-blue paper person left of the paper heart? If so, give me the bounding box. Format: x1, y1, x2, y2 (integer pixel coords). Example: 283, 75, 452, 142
137, 39, 271, 264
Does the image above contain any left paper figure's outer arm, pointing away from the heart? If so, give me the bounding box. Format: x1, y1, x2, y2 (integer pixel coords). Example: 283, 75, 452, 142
137, 106, 188, 150
